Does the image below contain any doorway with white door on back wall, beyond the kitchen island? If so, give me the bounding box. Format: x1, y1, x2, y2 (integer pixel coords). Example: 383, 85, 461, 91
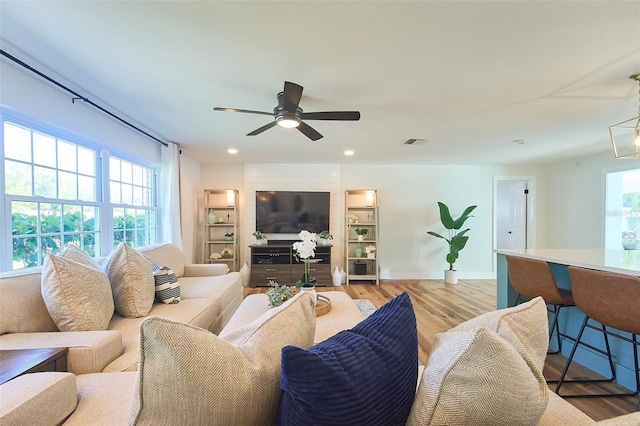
493, 176, 535, 250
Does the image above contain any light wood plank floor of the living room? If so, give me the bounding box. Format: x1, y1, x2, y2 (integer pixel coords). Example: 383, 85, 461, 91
244, 280, 638, 420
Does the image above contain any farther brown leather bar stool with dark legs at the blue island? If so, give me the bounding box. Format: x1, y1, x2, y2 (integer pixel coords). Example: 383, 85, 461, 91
506, 255, 575, 354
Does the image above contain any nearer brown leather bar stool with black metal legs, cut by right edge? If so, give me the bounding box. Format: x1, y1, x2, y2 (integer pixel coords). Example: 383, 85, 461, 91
556, 266, 640, 410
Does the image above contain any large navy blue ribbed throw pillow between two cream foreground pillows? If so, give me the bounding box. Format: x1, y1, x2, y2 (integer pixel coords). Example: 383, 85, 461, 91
277, 293, 418, 426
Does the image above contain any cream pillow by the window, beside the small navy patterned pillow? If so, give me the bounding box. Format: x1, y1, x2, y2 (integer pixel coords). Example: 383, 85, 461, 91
102, 243, 155, 318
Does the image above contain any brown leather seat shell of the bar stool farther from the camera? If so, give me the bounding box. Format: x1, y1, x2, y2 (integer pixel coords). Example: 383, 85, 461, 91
506, 256, 565, 305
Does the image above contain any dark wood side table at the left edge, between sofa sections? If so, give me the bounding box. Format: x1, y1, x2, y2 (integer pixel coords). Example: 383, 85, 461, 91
0, 348, 68, 384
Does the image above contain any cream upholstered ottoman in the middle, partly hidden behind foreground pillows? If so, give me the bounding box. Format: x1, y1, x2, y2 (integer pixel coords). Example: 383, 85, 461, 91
220, 291, 364, 343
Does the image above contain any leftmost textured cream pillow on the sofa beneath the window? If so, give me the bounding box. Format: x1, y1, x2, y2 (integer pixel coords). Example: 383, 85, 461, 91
40, 254, 113, 331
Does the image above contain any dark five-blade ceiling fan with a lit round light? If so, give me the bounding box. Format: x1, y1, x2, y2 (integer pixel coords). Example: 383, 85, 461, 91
214, 81, 360, 141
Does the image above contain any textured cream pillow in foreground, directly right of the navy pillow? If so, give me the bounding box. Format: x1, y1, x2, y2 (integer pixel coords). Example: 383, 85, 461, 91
407, 328, 548, 426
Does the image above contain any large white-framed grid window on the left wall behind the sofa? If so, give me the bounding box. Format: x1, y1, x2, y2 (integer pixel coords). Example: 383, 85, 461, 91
0, 112, 157, 270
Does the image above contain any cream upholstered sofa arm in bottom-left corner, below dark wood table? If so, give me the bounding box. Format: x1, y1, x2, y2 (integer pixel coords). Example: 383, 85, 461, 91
0, 372, 78, 426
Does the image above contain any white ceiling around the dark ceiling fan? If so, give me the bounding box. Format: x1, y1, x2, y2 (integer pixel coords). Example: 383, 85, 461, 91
0, 0, 640, 164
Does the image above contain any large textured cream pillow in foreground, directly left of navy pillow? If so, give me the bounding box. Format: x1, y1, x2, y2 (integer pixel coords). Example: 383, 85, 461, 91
132, 293, 316, 425
